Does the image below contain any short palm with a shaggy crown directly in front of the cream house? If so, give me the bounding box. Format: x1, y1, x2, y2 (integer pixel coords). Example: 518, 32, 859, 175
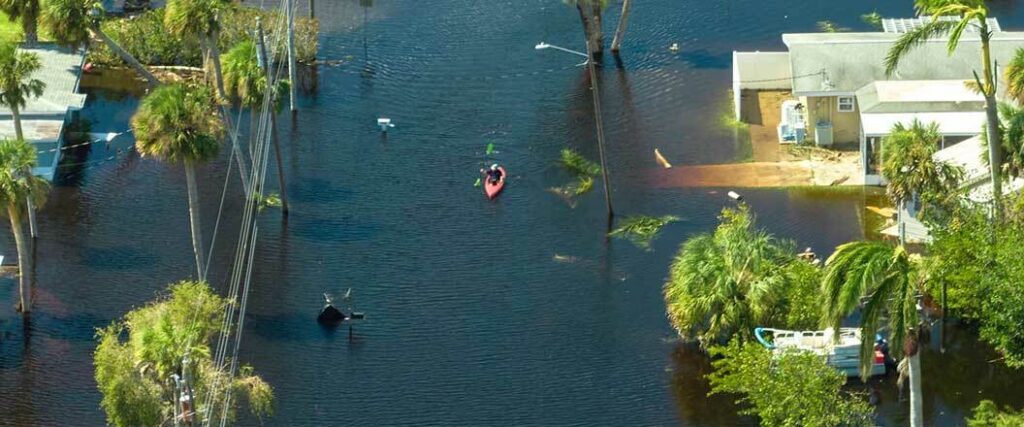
882, 119, 964, 236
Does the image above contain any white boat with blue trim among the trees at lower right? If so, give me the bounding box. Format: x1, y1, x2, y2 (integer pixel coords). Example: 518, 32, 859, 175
754, 328, 886, 377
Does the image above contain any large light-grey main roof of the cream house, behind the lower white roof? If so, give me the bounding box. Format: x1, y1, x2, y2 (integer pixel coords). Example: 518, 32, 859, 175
782, 32, 1024, 95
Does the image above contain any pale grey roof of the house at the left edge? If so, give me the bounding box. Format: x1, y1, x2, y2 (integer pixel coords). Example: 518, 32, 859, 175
0, 44, 85, 118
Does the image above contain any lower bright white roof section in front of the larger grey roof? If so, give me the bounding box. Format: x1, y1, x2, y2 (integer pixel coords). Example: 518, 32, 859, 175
857, 80, 985, 113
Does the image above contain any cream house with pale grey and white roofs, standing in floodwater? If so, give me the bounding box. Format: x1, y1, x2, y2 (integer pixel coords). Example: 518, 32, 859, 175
732, 17, 1024, 184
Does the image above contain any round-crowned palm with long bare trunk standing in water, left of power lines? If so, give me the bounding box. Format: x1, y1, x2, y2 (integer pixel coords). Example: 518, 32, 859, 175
131, 84, 224, 281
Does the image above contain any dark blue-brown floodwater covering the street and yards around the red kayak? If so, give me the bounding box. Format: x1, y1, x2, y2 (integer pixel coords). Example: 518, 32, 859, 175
0, 0, 1024, 426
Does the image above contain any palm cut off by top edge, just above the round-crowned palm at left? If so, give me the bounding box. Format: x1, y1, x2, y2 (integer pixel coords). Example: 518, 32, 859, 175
164, 0, 232, 99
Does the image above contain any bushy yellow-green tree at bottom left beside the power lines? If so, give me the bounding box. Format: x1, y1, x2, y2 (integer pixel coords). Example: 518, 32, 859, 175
93, 282, 273, 426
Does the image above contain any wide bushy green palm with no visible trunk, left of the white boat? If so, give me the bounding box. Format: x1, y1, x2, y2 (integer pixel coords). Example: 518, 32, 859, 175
663, 206, 796, 345
